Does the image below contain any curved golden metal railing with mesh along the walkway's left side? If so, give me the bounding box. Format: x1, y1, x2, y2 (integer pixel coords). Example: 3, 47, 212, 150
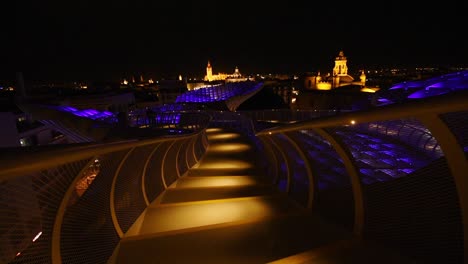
0, 116, 209, 263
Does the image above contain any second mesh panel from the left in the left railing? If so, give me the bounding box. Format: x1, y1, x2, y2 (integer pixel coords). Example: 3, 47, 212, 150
60, 151, 127, 263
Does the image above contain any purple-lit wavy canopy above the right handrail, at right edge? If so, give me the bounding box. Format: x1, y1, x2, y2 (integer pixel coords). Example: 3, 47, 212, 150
377, 70, 468, 105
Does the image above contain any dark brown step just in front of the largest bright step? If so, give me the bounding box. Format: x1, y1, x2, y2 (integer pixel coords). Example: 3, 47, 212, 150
117, 213, 349, 264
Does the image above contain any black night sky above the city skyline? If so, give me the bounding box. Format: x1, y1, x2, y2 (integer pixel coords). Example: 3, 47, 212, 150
10, 0, 468, 80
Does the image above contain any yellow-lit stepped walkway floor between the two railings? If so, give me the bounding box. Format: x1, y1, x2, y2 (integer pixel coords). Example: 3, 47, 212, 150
114, 128, 414, 263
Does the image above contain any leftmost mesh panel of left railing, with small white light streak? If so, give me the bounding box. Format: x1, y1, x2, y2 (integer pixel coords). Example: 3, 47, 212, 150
4, 160, 87, 263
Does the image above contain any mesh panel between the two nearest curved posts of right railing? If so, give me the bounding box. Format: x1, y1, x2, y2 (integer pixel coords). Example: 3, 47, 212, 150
328, 121, 462, 263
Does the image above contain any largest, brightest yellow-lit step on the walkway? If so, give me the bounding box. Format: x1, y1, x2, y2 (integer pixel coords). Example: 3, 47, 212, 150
127, 195, 302, 235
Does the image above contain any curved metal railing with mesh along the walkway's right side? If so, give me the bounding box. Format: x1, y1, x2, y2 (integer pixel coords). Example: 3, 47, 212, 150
256, 91, 468, 263
